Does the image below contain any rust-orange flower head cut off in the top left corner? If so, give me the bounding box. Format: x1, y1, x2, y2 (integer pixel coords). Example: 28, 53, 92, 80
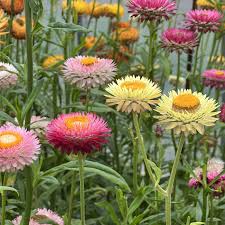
0, 0, 24, 15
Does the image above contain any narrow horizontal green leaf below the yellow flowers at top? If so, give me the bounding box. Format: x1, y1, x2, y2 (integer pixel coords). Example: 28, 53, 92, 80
42, 22, 88, 33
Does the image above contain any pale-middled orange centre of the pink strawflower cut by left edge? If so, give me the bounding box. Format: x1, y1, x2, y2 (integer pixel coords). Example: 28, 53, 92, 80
0, 131, 23, 149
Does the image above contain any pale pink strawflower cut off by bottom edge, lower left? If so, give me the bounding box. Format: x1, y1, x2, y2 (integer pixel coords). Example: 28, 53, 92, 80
12, 209, 64, 225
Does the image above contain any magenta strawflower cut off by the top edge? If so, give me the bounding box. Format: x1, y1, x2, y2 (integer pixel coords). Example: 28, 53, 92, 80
127, 0, 176, 22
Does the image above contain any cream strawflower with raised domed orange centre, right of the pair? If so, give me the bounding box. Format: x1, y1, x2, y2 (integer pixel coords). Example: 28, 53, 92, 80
155, 89, 219, 136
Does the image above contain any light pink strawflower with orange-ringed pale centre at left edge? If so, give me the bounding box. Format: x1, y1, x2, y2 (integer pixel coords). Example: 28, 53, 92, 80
0, 125, 40, 172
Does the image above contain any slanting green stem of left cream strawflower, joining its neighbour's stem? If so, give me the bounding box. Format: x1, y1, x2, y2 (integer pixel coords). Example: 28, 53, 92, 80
133, 113, 167, 196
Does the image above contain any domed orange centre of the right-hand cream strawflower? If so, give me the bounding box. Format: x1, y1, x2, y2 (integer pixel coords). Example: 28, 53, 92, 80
173, 94, 200, 111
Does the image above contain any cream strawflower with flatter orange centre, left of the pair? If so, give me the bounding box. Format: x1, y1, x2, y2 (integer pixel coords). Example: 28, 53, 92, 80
105, 76, 161, 113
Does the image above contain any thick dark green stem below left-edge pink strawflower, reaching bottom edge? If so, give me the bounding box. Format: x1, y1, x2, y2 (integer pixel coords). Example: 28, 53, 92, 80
22, 167, 33, 225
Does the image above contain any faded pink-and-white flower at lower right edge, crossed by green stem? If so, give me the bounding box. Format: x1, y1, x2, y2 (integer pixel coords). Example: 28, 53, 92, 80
189, 159, 225, 196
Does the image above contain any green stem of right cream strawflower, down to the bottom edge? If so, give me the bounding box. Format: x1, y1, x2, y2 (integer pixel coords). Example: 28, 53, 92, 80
165, 134, 185, 225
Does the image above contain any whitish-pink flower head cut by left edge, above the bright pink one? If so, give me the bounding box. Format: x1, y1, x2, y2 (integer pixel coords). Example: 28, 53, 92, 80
0, 62, 18, 89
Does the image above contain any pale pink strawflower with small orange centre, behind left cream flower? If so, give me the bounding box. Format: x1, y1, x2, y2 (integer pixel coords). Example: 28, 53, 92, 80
62, 56, 116, 89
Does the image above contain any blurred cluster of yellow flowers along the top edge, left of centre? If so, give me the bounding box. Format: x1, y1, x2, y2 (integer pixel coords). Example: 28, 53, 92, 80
62, 0, 124, 18
